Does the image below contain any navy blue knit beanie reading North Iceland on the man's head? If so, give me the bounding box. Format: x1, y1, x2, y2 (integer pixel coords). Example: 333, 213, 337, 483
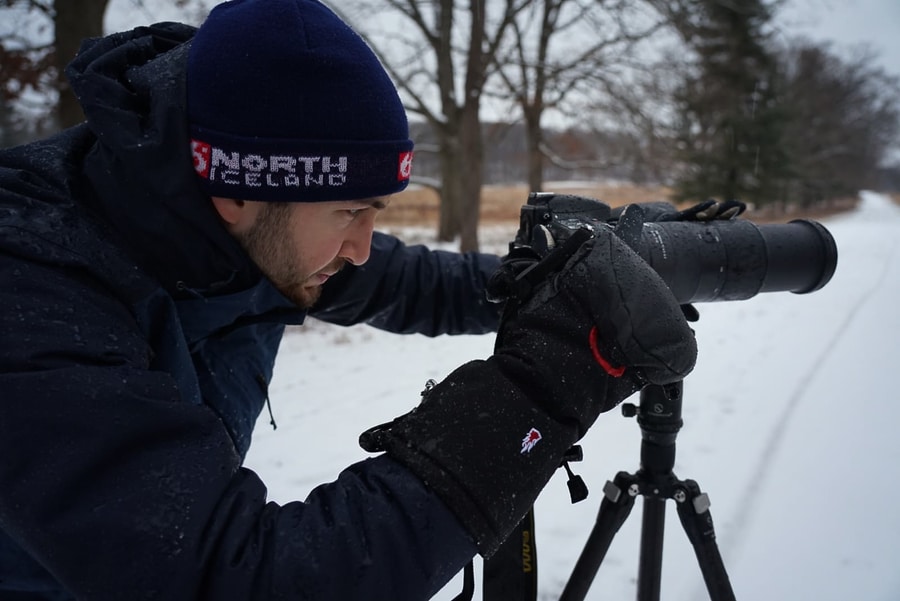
187, 0, 413, 202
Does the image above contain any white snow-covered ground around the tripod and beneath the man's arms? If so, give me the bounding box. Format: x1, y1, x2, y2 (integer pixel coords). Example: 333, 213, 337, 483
247, 193, 900, 601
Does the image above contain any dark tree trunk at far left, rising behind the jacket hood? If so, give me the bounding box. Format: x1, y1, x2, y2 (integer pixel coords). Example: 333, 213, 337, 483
53, 0, 109, 128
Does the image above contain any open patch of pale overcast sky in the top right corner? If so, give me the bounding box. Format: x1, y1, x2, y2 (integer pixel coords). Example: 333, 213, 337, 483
779, 0, 900, 76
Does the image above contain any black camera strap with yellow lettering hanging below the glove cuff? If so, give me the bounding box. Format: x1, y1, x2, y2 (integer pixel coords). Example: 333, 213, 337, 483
482, 508, 537, 601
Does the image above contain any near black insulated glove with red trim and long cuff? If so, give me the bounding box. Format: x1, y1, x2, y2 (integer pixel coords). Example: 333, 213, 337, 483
360, 218, 697, 557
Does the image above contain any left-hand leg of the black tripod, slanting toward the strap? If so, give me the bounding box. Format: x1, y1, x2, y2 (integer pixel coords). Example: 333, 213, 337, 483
559, 472, 638, 601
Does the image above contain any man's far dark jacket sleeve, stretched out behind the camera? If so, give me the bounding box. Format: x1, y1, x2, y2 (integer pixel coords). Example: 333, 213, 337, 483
310, 232, 501, 336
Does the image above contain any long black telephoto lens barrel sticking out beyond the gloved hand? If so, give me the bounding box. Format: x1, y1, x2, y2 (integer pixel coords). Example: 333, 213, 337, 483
638, 219, 837, 303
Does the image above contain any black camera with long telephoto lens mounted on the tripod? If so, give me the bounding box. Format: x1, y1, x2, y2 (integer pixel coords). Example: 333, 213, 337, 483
510, 192, 837, 304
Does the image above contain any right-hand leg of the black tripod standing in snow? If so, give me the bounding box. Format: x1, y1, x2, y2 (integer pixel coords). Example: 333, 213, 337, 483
675, 480, 735, 601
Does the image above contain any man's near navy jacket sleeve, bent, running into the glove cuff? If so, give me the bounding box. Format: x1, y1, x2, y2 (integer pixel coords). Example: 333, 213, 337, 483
0, 257, 475, 600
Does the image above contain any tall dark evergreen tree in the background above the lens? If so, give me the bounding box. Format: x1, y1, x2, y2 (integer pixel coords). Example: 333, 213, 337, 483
673, 0, 786, 204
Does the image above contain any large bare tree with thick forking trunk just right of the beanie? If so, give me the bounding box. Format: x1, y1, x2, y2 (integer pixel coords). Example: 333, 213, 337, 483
343, 0, 530, 251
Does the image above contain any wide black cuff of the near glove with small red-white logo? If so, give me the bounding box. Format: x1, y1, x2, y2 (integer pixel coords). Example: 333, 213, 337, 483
366, 357, 578, 557
